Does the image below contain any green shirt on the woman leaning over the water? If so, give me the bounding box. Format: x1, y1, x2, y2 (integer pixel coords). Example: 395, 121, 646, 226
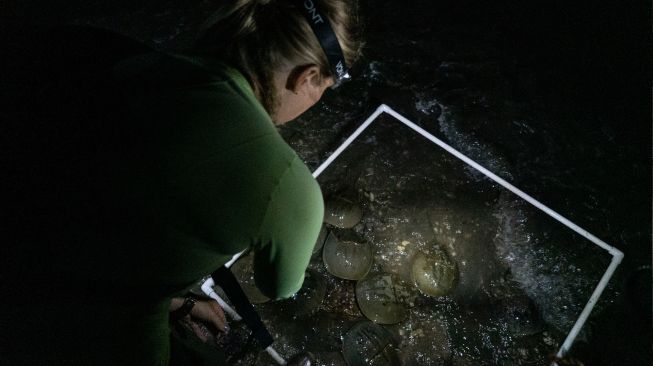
115, 54, 323, 298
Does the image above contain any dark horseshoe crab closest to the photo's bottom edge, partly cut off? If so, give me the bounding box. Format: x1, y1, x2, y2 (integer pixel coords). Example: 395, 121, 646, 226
342, 321, 401, 366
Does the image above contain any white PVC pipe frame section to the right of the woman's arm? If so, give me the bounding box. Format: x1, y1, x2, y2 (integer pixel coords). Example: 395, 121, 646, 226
313, 104, 624, 365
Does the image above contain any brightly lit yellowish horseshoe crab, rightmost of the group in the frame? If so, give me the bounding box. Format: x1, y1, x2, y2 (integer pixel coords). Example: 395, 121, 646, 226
410, 249, 458, 297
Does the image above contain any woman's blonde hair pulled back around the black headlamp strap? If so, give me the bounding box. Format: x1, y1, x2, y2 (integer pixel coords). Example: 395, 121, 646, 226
195, 0, 362, 114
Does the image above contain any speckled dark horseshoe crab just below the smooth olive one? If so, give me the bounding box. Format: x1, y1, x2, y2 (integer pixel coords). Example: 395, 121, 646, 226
356, 273, 415, 324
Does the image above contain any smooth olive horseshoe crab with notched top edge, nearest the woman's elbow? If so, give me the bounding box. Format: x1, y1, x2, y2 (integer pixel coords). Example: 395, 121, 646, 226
322, 232, 374, 280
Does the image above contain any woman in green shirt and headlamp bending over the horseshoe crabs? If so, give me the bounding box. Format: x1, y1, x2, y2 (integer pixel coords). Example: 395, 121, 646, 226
0, 0, 359, 365
